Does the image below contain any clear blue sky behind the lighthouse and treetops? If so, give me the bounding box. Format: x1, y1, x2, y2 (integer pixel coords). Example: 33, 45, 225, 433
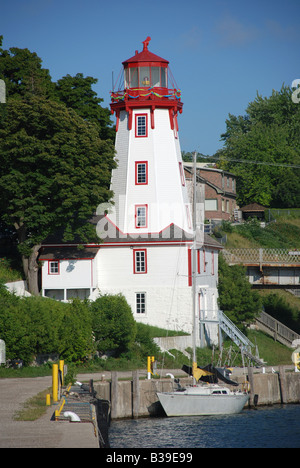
0, 0, 300, 155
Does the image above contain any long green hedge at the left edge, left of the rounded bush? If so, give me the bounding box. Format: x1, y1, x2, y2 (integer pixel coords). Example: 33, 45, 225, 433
0, 287, 93, 364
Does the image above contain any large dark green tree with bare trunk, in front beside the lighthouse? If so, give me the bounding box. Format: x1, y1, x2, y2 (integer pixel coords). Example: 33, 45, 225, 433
0, 96, 115, 294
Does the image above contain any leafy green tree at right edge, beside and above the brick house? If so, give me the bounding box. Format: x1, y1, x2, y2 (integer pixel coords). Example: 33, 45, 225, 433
217, 86, 300, 208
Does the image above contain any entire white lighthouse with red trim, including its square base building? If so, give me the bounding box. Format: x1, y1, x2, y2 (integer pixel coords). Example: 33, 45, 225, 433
41, 38, 220, 344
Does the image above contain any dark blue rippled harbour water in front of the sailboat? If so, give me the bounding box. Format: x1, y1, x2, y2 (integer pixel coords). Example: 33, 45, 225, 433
109, 405, 300, 449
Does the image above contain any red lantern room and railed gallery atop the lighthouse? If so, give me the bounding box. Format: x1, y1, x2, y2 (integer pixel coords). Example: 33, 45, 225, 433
110, 37, 183, 131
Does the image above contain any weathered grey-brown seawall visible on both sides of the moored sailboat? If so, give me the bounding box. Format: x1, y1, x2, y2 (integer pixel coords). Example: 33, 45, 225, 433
94, 367, 300, 419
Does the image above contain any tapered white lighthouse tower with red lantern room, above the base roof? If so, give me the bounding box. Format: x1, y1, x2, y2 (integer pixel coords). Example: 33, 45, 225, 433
111, 37, 192, 235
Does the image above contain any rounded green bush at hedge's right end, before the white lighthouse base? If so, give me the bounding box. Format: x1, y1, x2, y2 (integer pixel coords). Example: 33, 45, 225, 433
91, 294, 136, 356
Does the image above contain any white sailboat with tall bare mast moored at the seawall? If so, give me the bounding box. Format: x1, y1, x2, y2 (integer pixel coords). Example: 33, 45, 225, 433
157, 154, 249, 416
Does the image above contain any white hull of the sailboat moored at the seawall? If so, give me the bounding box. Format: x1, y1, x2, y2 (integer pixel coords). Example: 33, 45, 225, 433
157, 392, 249, 417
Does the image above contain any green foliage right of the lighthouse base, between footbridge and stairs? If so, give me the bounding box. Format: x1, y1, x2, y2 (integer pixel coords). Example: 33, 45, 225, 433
218, 254, 261, 332
